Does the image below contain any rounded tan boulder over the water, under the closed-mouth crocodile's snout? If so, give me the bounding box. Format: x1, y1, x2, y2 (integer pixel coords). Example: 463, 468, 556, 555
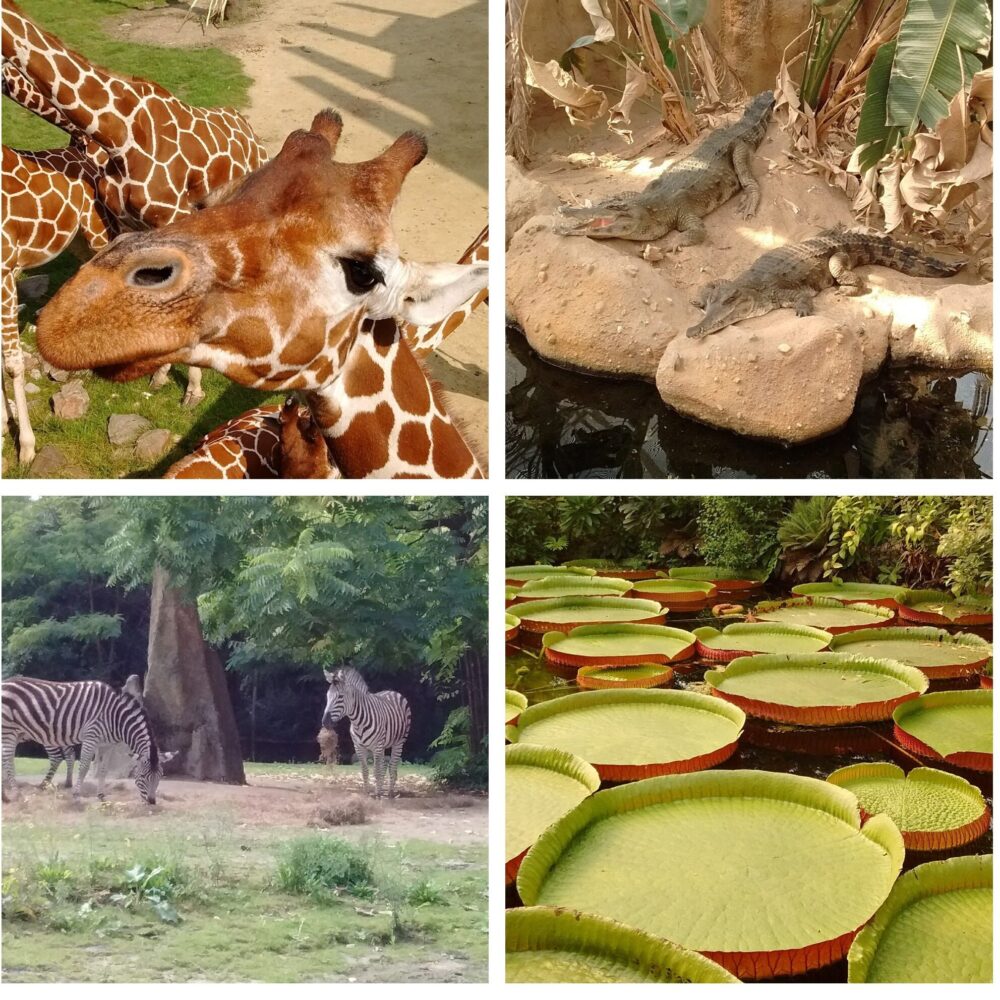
656, 310, 864, 443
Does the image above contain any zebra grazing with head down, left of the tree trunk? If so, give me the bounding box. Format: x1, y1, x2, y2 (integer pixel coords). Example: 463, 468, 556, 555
0, 677, 163, 805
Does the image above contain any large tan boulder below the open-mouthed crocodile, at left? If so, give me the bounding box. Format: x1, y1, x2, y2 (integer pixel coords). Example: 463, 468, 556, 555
507, 216, 699, 379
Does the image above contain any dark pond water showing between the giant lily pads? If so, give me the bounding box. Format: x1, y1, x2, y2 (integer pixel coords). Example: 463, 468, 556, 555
506, 596, 993, 982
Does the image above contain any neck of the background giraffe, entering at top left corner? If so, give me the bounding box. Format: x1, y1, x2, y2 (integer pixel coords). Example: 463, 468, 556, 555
3, 3, 148, 153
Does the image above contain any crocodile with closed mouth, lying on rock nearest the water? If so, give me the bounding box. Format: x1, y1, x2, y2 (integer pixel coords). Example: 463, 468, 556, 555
687, 226, 966, 340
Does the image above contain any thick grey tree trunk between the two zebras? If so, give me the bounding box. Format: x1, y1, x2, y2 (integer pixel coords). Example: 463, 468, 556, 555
145, 566, 246, 785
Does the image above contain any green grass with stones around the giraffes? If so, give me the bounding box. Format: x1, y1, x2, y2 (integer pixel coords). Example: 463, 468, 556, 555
3, 0, 279, 478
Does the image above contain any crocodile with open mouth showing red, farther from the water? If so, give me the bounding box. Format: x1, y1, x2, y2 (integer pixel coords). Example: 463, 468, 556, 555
556, 90, 774, 248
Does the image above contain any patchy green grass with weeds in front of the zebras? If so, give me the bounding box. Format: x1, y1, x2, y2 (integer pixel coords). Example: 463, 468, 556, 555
3, 758, 487, 982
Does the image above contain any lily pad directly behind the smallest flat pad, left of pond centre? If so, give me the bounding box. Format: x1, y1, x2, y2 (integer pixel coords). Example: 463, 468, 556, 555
542, 625, 695, 669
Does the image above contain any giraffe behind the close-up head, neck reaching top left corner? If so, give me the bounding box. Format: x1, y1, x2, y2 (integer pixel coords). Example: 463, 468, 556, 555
2, 0, 267, 406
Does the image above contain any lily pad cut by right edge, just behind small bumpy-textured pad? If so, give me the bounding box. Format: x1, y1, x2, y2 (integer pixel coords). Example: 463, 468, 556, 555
892, 690, 993, 771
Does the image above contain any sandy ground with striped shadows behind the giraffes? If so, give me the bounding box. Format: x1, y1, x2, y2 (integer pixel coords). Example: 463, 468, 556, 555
118, 0, 488, 460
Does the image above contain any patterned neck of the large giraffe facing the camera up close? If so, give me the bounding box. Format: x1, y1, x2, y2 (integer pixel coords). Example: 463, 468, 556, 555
306, 319, 482, 479
